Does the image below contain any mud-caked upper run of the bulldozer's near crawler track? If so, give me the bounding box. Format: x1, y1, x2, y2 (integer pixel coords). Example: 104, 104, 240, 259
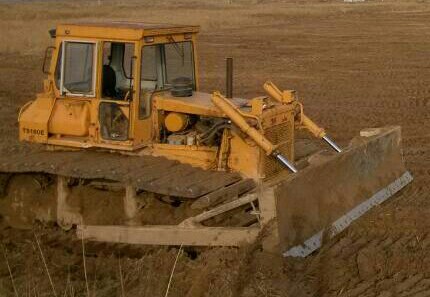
0, 151, 242, 199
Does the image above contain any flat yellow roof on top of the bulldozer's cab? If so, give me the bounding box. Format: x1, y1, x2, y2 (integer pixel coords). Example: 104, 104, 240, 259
56, 21, 200, 40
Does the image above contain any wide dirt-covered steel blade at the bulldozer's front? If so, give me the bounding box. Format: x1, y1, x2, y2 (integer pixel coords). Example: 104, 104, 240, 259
274, 123, 412, 257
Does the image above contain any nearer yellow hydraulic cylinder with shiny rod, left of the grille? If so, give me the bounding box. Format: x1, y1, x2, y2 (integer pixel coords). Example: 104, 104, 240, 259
212, 92, 298, 173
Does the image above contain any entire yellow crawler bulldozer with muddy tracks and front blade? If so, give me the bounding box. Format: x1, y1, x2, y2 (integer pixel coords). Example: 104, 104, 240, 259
0, 21, 412, 257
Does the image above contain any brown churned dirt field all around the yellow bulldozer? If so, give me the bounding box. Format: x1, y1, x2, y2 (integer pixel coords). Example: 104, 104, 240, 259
0, 0, 430, 297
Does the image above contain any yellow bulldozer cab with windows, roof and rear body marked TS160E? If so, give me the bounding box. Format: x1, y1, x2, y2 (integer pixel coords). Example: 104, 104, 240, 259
19, 22, 198, 150
